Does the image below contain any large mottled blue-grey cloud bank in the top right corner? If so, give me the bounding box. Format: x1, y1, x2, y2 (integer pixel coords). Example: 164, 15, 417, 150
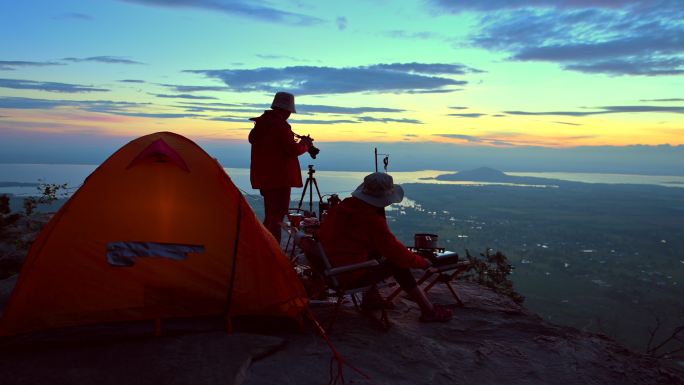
432, 0, 684, 76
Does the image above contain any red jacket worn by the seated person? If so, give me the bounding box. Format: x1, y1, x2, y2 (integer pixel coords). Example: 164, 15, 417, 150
319, 197, 428, 279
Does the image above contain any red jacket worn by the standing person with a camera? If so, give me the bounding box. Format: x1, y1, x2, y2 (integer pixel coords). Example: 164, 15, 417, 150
249, 110, 308, 189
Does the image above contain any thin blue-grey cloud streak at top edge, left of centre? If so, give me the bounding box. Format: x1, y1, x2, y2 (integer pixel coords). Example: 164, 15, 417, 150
120, 0, 323, 26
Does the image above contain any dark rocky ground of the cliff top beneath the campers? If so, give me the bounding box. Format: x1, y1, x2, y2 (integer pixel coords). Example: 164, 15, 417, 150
0, 212, 684, 385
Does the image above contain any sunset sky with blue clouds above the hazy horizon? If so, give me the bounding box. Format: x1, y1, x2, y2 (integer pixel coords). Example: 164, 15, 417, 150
0, 0, 684, 170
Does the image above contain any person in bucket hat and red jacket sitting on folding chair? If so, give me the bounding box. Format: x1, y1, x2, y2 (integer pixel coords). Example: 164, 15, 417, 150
319, 172, 451, 322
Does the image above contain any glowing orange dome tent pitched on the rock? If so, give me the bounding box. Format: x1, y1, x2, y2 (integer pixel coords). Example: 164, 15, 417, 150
0, 132, 307, 335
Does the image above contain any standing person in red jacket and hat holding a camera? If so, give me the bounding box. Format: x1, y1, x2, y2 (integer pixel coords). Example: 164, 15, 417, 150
249, 92, 312, 243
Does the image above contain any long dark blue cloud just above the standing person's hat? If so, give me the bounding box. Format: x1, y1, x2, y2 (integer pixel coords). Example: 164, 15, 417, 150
184, 63, 478, 95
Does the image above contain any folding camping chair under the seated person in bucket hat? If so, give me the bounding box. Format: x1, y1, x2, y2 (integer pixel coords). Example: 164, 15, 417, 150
295, 231, 393, 332
